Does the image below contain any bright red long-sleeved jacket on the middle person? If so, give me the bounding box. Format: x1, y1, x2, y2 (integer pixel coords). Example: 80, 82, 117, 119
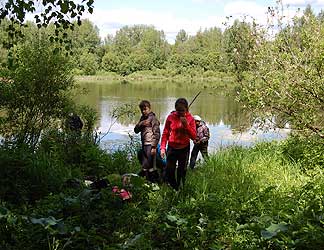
161, 111, 196, 150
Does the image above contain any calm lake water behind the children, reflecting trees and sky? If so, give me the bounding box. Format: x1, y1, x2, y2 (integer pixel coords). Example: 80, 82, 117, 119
77, 82, 289, 151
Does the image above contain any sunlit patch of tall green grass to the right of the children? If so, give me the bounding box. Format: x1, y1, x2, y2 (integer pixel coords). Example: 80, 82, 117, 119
146, 143, 324, 249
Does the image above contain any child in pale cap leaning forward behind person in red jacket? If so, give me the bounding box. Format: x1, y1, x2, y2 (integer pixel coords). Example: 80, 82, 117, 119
189, 115, 210, 169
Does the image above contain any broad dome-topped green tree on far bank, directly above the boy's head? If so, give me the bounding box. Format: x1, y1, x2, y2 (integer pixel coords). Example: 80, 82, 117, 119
101, 25, 169, 75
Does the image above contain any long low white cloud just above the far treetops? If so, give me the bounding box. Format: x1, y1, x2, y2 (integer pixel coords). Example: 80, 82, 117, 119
86, 9, 224, 42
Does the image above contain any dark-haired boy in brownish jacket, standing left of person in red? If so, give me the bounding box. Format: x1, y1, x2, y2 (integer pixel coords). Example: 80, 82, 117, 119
134, 100, 160, 181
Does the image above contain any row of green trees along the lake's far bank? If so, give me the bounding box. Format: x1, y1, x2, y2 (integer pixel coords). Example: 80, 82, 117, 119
0, 15, 258, 76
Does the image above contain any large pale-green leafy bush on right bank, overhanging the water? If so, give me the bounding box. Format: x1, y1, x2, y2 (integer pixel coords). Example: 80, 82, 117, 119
239, 3, 324, 138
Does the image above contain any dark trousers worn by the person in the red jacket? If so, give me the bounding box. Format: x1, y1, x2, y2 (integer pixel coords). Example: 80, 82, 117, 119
165, 146, 190, 190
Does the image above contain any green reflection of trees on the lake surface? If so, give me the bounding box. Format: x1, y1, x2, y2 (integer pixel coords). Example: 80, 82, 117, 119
74, 82, 251, 131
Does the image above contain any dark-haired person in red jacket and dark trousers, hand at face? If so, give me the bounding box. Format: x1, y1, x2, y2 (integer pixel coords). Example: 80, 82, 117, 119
161, 98, 196, 190
